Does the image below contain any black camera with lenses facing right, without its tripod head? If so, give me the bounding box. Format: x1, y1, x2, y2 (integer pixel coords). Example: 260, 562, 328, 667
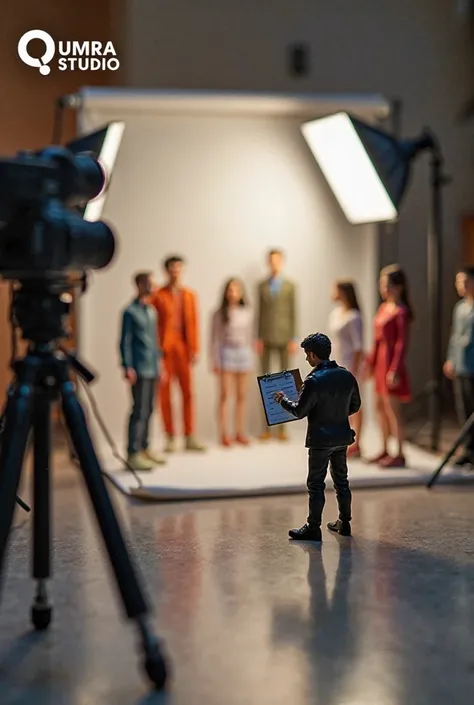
0, 147, 115, 282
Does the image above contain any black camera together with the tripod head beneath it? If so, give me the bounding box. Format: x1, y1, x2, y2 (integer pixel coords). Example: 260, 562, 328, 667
0, 147, 115, 345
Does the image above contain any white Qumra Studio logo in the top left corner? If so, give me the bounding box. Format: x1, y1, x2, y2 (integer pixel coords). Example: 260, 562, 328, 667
18, 29, 120, 76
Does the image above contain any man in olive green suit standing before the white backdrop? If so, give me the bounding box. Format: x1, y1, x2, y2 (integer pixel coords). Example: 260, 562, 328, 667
257, 250, 298, 440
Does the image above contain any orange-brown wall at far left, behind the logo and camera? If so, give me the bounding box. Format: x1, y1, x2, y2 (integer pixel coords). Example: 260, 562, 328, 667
0, 0, 120, 403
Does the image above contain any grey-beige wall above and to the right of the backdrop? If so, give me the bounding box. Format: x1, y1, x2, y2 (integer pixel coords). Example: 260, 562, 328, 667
117, 0, 474, 396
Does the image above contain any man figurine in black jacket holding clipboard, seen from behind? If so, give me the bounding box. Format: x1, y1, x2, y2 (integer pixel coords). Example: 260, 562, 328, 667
274, 333, 361, 541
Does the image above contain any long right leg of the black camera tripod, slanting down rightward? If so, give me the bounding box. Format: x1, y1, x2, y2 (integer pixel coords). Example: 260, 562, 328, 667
61, 373, 167, 689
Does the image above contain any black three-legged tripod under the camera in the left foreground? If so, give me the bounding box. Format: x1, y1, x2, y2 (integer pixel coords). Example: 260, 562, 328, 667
0, 338, 167, 689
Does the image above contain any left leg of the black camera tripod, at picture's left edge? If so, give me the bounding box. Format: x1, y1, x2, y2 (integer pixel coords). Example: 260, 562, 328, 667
0, 376, 36, 574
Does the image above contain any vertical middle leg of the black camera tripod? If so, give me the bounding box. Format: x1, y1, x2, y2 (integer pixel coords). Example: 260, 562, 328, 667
31, 392, 52, 630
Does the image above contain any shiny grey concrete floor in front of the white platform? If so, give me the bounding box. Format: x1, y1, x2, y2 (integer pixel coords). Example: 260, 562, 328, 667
0, 470, 474, 705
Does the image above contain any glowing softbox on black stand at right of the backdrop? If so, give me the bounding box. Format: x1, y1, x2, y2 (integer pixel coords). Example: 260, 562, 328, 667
301, 113, 449, 450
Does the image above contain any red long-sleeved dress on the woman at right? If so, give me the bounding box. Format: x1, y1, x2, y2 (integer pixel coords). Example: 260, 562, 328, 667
368, 303, 411, 402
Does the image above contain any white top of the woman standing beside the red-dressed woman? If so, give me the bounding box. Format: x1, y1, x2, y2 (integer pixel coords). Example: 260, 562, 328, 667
329, 306, 364, 371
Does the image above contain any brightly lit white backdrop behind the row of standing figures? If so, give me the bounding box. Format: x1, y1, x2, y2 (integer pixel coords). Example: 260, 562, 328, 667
80, 91, 377, 442
